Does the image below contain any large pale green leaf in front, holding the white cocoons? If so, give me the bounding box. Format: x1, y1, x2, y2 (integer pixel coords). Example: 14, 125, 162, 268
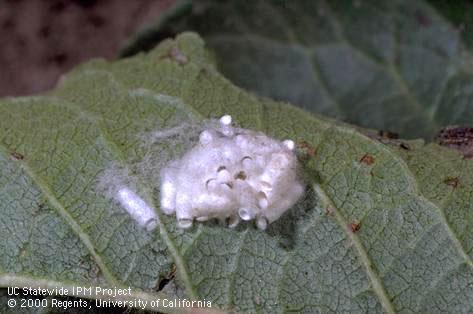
0, 33, 473, 313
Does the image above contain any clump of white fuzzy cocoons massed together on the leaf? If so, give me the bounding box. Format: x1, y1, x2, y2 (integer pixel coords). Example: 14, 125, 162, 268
160, 115, 304, 230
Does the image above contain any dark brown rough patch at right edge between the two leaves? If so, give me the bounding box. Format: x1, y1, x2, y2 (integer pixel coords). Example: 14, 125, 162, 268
436, 126, 473, 158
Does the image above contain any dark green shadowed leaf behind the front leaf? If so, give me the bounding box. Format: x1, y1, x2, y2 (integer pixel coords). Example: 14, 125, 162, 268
123, 0, 473, 139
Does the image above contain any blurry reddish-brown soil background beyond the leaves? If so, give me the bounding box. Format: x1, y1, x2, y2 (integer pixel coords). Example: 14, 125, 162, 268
0, 0, 174, 96
